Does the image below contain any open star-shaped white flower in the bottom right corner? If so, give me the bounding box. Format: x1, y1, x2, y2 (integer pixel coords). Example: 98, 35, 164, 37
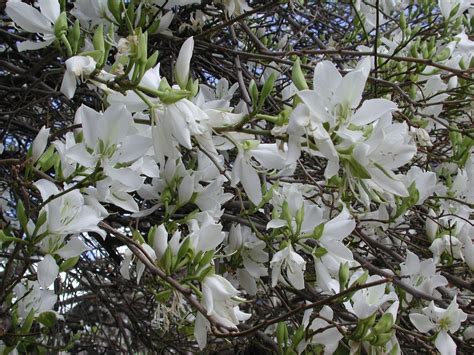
410, 296, 467, 355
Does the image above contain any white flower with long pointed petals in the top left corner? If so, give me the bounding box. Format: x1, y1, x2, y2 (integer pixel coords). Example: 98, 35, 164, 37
5, 0, 61, 52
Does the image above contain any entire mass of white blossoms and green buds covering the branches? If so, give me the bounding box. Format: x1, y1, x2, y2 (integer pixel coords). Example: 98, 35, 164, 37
1, 0, 474, 354
